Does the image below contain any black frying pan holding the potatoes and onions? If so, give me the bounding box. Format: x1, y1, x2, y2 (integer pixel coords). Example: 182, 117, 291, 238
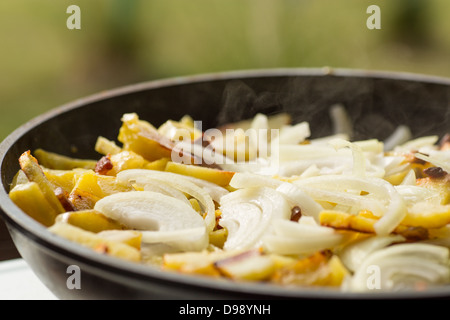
0, 68, 450, 300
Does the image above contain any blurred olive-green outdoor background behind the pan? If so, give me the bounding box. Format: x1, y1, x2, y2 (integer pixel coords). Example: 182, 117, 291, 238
0, 0, 450, 139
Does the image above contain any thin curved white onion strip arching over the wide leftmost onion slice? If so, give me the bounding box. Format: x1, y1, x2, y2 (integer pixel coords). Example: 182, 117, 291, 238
117, 169, 216, 231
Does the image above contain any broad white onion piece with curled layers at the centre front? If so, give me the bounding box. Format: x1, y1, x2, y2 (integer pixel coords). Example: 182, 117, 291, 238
219, 187, 291, 250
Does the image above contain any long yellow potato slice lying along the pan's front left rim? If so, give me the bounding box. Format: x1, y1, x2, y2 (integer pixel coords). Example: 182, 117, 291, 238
48, 222, 141, 262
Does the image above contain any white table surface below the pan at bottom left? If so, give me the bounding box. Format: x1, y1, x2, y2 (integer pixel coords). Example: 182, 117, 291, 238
0, 259, 57, 300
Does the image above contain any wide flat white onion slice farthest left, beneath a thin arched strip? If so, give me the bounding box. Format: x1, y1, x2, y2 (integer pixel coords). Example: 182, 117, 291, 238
94, 191, 208, 250
